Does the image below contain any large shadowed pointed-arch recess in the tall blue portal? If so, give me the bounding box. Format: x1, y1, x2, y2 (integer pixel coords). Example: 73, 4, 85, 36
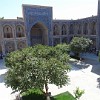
30, 22, 48, 46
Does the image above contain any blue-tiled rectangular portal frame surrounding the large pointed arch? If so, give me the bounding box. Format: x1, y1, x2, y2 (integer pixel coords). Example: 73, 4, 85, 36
23, 5, 52, 45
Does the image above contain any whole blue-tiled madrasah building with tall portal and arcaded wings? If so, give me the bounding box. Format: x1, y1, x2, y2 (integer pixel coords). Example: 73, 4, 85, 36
0, 0, 100, 55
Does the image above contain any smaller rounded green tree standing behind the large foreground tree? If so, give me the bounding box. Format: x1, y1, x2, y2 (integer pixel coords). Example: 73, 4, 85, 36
70, 37, 92, 56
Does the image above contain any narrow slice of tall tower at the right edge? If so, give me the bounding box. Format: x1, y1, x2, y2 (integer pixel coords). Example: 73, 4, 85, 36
96, 0, 100, 50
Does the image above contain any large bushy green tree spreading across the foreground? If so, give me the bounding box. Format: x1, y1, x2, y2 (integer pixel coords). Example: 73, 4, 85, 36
5, 45, 70, 99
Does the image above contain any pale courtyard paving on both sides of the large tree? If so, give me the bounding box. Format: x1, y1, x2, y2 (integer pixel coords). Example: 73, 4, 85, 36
0, 55, 100, 100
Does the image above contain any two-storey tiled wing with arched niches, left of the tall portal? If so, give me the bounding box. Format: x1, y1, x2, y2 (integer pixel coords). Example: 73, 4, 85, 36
0, 19, 27, 55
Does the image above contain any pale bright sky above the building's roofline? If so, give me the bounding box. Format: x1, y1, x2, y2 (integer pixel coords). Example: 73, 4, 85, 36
0, 0, 98, 19
